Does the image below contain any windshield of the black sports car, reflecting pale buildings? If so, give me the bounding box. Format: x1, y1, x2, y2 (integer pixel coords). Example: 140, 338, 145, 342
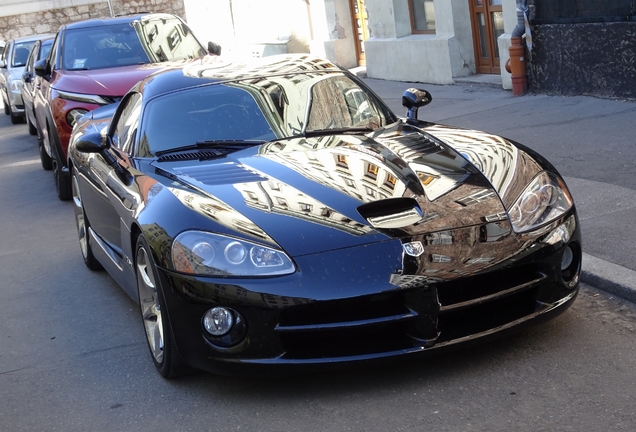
140, 73, 397, 156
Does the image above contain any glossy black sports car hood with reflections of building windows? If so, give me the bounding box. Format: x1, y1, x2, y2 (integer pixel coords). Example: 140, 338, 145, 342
152, 120, 538, 260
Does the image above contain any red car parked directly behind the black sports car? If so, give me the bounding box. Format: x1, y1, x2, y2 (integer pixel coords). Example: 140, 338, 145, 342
34, 13, 220, 200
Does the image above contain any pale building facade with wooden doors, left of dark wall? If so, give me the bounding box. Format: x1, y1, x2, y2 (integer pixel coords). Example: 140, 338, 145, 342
184, 0, 517, 88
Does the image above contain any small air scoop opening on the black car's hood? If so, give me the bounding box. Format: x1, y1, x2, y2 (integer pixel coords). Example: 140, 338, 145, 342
358, 198, 424, 229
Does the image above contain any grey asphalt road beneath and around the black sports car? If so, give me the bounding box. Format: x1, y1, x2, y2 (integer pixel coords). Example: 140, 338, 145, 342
0, 88, 636, 432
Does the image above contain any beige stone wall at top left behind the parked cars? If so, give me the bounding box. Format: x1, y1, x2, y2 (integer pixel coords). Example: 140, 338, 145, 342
0, 0, 186, 40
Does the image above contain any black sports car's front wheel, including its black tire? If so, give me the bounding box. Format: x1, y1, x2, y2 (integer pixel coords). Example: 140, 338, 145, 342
135, 235, 189, 378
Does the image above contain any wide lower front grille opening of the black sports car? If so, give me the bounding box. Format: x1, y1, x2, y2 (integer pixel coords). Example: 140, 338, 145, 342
276, 265, 547, 360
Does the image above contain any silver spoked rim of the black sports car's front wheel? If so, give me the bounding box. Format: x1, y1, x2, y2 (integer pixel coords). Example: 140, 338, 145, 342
136, 246, 164, 364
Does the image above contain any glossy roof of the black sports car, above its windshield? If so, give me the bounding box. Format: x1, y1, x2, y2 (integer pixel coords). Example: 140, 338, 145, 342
133, 54, 345, 99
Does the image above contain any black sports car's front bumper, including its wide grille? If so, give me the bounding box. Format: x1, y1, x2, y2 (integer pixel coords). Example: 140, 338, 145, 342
159, 216, 581, 374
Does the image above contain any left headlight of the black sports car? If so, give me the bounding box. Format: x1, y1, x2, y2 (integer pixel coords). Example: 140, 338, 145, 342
172, 231, 295, 276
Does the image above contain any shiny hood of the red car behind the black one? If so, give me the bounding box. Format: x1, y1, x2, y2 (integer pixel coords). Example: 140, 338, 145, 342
53, 63, 168, 97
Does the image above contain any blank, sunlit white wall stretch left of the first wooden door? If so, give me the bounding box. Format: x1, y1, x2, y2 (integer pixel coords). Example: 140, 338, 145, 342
184, 0, 357, 67
